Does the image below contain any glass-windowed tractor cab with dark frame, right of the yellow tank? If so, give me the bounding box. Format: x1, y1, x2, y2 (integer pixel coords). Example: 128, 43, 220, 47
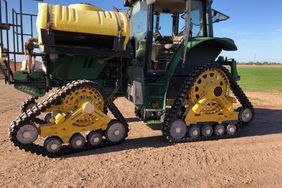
125, 0, 229, 74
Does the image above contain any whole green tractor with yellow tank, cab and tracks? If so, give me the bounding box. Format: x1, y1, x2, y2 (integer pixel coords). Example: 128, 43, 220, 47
1, 0, 254, 156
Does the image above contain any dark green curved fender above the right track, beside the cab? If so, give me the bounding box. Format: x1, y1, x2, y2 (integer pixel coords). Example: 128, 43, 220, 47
167, 37, 237, 98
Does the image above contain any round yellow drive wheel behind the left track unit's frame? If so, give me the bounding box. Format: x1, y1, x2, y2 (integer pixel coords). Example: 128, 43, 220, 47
61, 87, 105, 127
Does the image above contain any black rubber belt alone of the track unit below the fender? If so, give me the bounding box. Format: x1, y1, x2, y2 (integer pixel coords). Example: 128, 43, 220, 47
162, 63, 254, 143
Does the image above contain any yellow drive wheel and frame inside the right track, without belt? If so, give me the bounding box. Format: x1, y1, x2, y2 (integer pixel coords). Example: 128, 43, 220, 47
185, 68, 239, 125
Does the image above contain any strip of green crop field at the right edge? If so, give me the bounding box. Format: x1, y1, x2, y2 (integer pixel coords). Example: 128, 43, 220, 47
238, 66, 282, 92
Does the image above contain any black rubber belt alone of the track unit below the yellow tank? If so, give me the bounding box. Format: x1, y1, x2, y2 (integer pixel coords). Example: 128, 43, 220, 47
9, 80, 129, 157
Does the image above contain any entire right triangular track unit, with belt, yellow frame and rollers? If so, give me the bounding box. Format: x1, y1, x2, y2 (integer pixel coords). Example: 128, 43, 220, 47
162, 64, 254, 143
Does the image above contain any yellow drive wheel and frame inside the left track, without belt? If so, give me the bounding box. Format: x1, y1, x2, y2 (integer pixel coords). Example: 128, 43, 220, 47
39, 87, 111, 143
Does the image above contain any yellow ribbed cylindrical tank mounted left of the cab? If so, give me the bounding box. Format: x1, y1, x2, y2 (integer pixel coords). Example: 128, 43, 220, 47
37, 3, 130, 49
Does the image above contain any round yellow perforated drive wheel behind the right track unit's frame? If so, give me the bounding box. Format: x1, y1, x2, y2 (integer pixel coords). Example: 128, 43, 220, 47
190, 68, 230, 114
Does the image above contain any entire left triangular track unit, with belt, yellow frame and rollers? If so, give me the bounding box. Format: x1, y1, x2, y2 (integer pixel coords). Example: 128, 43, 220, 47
10, 80, 128, 157
